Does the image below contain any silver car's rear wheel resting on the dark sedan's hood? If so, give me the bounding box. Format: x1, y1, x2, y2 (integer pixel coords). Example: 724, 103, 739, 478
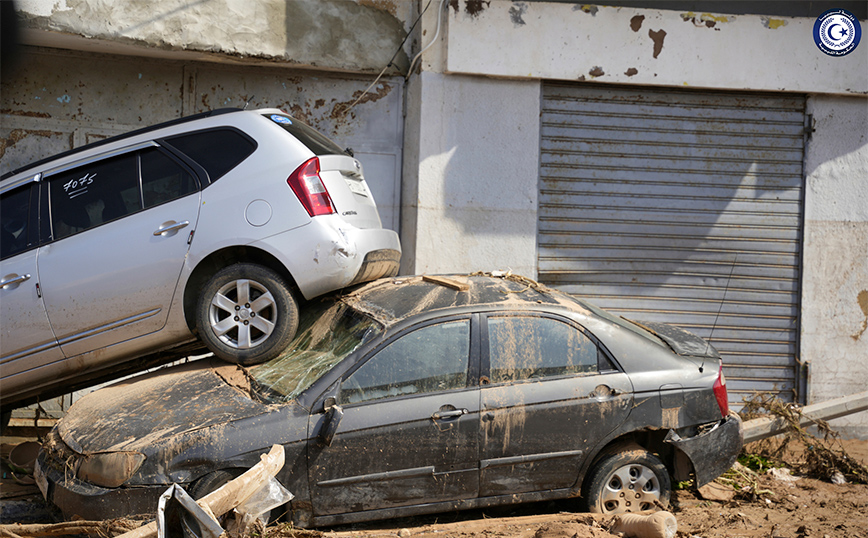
196, 263, 298, 366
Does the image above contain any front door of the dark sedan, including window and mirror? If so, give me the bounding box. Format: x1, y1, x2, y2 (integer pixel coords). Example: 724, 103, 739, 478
308, 317, 479, 516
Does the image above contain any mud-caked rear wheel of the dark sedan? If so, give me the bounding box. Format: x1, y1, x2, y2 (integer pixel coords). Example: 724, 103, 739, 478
582, 450, 672, 514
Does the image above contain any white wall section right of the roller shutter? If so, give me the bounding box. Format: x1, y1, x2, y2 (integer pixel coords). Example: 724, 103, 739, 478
801, 96, 868, 439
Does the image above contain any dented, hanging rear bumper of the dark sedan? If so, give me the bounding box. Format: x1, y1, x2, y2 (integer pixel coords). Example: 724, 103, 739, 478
664, 413, 744, 488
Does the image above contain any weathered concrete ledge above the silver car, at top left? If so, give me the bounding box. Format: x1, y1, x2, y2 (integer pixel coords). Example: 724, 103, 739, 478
16, 0, 415, 74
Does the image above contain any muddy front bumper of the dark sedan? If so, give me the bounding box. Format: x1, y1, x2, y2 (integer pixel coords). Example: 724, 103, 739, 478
34, 452, 169, 521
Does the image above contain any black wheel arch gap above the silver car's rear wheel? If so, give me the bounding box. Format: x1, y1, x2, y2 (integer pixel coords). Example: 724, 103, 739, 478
184, 246, 304, 334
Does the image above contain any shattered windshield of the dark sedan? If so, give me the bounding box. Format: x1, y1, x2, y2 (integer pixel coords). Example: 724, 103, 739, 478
250, 301, 383, 402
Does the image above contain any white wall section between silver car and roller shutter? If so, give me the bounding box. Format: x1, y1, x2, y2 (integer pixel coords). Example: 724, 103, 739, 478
403, 71, 540, 278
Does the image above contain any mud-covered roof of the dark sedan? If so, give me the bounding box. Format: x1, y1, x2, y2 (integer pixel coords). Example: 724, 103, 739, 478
342, 273, 590, 326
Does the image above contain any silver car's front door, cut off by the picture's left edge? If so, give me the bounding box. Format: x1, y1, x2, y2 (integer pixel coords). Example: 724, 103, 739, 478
0, 182, 63, 399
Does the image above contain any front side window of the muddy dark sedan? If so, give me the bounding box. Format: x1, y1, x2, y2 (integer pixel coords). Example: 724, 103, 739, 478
338, 320, 470, 404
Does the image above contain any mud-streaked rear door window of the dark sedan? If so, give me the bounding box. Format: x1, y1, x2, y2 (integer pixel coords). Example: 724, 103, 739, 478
488, 316, 599, 383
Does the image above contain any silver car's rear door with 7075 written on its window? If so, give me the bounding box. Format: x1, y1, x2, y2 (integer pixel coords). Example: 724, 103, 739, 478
39, 145, 199, 357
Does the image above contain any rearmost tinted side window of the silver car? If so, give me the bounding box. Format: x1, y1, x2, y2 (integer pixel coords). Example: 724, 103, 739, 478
165, 128, 256, 183
